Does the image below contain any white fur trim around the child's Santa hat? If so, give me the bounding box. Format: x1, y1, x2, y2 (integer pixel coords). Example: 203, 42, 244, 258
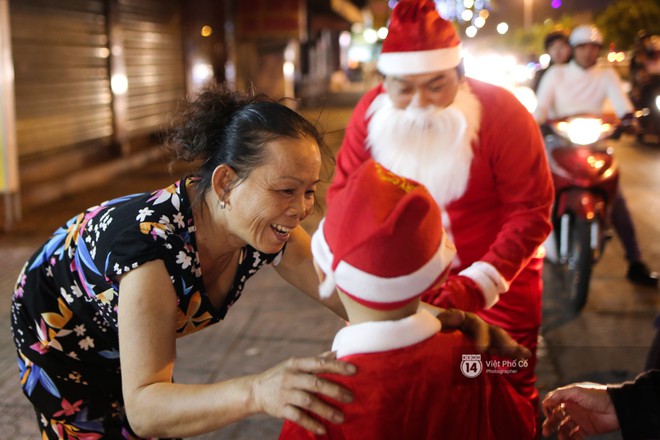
312, 219, 456, 303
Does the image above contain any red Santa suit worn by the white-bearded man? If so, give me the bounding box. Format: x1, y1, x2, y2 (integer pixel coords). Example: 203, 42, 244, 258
328, 77, 553, 410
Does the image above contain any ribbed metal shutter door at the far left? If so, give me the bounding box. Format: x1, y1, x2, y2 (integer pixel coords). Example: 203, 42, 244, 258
10, 0, 113, 161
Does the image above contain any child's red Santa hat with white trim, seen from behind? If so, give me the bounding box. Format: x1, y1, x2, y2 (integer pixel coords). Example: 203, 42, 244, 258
312, 160, 456, 310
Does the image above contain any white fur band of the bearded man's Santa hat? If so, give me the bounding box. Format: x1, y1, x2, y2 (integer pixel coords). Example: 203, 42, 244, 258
378, 44, 462, 75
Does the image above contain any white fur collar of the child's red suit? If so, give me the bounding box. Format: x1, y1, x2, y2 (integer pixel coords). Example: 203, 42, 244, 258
332, 310, 441, 358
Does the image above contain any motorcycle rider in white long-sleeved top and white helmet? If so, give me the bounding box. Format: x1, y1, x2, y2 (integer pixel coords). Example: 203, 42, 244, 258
534, 25, 658, 287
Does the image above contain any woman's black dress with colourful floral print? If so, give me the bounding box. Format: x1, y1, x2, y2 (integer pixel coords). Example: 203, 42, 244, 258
11, 178, 280, 439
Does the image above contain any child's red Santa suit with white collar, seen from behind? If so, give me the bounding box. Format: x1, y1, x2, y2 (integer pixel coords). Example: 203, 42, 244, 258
280, 311, 535, 440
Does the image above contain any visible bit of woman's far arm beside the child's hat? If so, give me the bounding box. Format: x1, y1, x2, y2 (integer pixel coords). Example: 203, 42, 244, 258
275, 226, 348, 320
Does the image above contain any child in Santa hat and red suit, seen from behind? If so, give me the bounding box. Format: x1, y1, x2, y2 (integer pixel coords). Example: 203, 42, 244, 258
280, 160, 535, 440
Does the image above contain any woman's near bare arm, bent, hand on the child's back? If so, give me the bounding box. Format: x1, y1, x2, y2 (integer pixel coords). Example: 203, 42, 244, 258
119, 260, 354, 437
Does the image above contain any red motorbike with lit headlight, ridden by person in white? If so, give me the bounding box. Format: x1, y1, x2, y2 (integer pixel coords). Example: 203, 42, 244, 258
543, 115, 622, 314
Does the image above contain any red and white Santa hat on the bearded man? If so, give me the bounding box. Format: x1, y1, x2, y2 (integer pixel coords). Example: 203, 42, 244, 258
378, 0, 461, 75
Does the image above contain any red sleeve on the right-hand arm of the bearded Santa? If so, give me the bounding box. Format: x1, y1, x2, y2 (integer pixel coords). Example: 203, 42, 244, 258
470, 82, 554, 281
